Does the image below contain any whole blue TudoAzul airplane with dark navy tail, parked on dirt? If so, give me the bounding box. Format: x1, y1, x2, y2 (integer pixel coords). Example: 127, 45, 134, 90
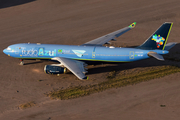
3, 22, 176, 80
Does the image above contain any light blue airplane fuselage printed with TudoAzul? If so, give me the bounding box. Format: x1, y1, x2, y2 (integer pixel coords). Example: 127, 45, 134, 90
3, 43, 168, 62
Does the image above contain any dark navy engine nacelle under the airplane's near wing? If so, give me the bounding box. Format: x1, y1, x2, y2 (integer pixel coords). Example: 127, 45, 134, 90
44, 65, 66, 74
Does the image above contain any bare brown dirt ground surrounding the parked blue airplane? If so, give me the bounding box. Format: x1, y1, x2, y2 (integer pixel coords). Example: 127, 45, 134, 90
0, 0, 180, 120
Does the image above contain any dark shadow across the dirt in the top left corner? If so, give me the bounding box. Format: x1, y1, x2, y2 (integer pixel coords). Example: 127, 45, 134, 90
0, 0, 36, 9
